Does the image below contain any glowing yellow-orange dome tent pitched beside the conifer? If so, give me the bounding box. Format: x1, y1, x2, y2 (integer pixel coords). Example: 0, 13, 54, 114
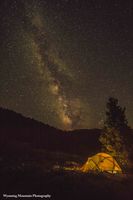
81, 153, 122, 174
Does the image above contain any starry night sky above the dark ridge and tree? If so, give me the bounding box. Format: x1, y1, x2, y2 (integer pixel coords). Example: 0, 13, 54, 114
0, 0, 133, 129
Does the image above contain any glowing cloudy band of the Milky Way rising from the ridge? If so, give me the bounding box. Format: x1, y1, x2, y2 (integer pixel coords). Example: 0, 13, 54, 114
22, 4, 83, 130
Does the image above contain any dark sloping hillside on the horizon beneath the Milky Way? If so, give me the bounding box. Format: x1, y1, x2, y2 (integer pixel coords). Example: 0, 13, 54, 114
0, 108, 101, 156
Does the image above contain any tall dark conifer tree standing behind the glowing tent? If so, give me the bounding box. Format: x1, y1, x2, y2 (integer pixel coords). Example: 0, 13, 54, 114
99, 97, 129, 169
